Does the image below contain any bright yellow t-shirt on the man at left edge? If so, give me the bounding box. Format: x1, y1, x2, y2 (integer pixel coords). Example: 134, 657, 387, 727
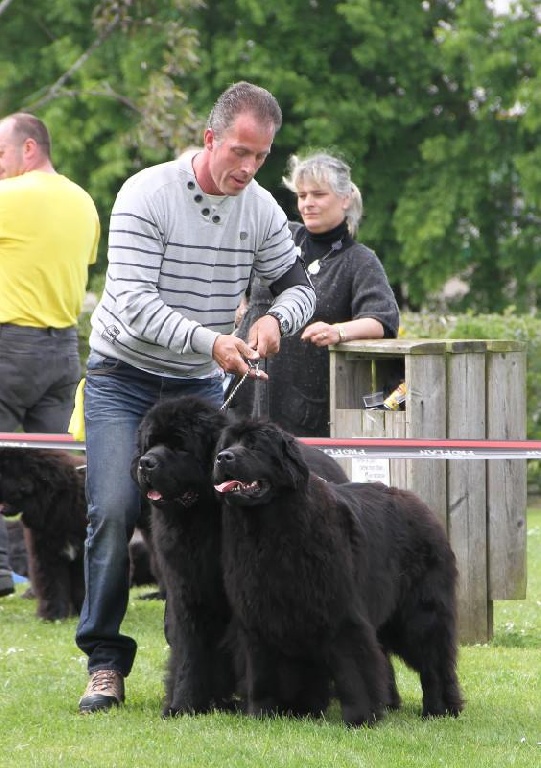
0, 171, 100, 328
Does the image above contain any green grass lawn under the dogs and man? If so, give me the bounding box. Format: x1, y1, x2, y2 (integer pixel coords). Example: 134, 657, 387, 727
0, 510, 541, 768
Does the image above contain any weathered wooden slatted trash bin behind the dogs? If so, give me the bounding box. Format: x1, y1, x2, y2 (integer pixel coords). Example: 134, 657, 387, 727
330, 339, 527, 643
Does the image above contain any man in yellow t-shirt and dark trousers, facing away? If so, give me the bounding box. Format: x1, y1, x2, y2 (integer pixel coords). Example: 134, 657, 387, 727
0, 112, 100, 596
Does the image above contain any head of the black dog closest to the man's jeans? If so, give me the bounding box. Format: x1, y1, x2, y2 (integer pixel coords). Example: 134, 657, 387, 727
132, 395, 226, 508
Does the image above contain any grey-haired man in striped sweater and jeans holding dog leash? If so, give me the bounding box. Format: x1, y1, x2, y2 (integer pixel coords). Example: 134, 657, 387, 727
76, 82, 315, 712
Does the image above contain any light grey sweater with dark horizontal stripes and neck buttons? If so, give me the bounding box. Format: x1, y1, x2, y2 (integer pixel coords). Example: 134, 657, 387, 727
90, 154, 315, 378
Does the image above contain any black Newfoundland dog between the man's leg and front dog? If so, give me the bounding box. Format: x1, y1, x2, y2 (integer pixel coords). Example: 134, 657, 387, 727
132, 396, 347, 716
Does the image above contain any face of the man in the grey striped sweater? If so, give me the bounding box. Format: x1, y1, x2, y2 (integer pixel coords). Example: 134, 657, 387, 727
205, 113, 274, 195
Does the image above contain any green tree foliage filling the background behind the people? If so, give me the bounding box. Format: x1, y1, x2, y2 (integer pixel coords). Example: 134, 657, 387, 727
0, 0, 541, 311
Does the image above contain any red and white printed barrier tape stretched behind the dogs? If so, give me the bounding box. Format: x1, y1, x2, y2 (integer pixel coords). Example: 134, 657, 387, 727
0, 432, 541, 459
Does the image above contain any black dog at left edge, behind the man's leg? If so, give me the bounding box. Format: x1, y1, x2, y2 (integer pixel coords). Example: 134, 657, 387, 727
0, 447, 87, 621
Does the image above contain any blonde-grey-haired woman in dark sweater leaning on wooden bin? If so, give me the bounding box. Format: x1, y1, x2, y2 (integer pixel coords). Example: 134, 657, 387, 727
231, 152, 399, 437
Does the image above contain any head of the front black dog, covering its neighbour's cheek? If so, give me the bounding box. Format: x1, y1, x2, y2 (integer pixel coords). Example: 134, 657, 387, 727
213, 420, 309, 507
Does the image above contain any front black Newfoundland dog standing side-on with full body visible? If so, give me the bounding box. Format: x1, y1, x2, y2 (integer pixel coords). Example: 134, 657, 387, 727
213, 421, 463, 725
